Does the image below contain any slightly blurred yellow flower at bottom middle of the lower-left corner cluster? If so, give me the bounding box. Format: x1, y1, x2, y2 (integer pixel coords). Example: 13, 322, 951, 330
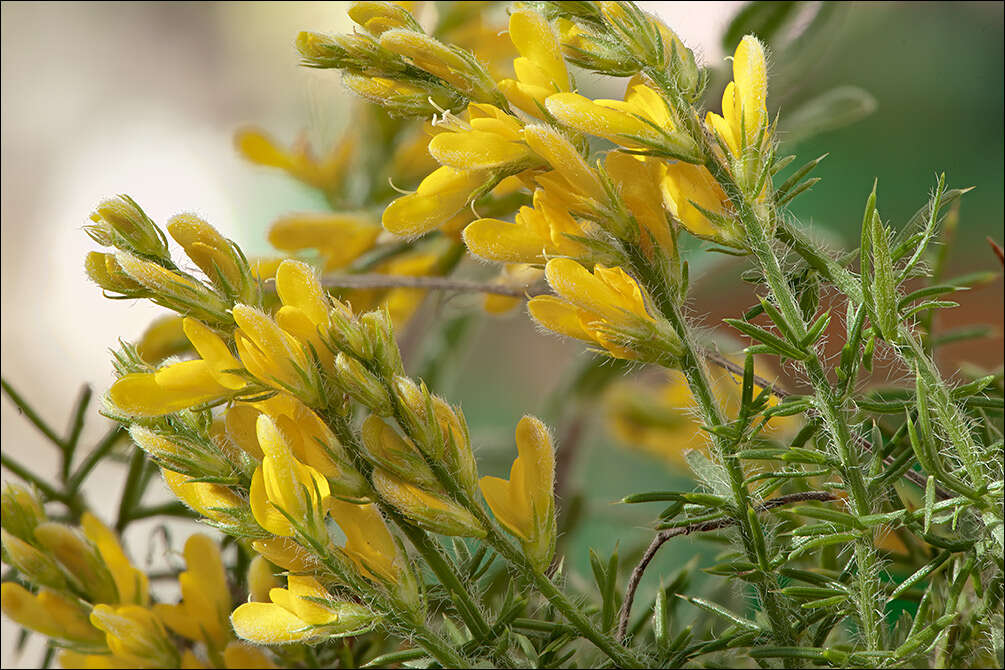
90, 605, 179, 668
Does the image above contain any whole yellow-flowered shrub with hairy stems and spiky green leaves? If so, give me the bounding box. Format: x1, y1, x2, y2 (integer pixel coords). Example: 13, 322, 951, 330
2, 2, 1003, 668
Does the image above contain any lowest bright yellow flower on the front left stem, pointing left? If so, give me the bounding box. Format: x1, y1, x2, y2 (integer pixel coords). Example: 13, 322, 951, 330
230, 575, 375, 645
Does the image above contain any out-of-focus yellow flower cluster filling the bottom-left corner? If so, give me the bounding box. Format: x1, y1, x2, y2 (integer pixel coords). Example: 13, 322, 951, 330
2, 484, 275, 668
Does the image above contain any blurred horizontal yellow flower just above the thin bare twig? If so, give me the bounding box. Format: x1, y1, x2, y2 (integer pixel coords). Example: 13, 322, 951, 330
268, 212, 381, 272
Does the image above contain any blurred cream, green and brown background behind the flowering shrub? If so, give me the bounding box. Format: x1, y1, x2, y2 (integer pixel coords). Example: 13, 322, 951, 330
0, 2, 1003, 667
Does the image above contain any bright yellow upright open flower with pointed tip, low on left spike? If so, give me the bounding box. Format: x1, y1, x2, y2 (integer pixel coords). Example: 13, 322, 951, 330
250, 414, 331, 541
